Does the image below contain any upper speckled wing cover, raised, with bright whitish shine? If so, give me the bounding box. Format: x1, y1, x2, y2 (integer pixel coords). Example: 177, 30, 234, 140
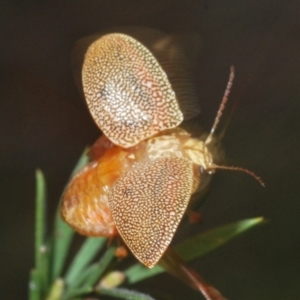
82, 33, 183, 148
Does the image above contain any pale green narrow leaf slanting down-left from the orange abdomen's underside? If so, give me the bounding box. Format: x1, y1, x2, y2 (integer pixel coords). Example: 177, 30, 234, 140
65, 237, 106, 285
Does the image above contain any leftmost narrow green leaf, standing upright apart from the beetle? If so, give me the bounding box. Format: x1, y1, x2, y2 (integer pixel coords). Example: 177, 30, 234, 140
35, 170, 48, 296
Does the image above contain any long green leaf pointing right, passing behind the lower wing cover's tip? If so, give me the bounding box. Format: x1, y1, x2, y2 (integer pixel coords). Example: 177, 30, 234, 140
125, 217, 264, 284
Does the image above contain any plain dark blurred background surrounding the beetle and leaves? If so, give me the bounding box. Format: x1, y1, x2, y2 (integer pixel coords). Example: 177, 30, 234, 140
0, 0, 300, 300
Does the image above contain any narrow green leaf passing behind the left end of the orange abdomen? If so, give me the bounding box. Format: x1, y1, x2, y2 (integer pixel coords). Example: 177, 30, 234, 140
51, 149, 89, 281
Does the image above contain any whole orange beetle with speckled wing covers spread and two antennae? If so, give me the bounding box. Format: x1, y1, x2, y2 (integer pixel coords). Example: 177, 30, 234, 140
61, 33, 262, 268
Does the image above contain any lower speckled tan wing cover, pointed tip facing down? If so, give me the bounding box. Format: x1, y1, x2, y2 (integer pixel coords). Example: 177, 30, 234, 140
108, 157, 193, 268
